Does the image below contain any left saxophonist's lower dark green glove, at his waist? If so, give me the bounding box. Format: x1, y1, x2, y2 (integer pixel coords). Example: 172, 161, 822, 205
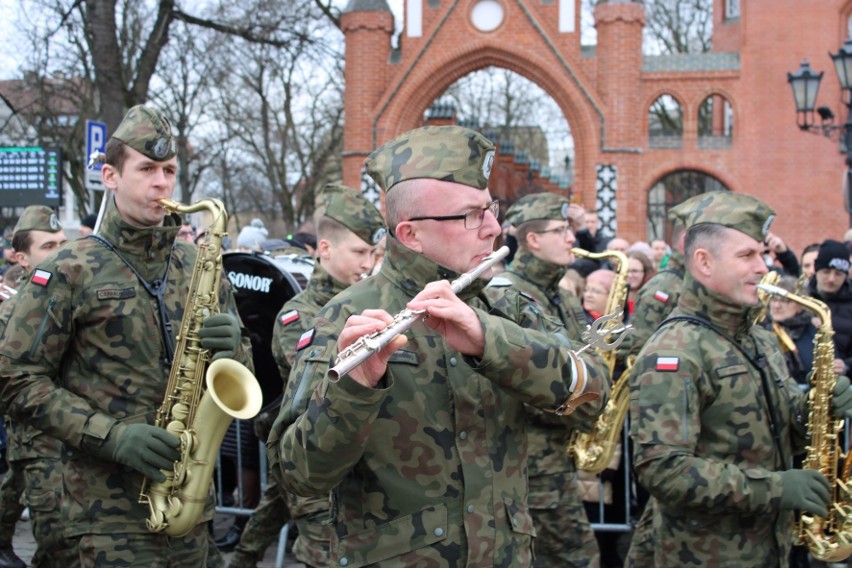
96, 424, 180, 482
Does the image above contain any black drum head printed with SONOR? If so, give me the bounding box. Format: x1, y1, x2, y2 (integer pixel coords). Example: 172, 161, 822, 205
222, 252, 310, 405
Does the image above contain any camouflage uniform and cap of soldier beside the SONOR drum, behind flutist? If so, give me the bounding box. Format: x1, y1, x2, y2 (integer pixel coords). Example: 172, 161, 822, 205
230, 185, 385, 568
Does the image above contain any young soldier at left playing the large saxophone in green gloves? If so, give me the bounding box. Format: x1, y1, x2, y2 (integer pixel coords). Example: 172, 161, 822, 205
0, 105, 251, 568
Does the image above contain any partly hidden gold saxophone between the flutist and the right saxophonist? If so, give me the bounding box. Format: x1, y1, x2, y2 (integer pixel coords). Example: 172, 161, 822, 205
567, 249, 635, 473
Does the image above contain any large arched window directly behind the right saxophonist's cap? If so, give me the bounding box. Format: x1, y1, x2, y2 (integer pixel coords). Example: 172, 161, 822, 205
648, 170, 730, 243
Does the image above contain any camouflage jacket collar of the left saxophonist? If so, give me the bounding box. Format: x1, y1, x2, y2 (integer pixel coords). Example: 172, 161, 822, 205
98, 193, 180, 281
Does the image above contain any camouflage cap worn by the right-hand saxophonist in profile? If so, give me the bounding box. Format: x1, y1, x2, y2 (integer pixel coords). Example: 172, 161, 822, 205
685, 191, 775, 242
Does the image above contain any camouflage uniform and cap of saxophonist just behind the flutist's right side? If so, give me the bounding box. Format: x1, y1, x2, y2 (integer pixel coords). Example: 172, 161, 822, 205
486, 193, 600, 567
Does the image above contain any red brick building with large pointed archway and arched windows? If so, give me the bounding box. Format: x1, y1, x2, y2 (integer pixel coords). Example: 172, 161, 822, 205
342, 0, 852, 251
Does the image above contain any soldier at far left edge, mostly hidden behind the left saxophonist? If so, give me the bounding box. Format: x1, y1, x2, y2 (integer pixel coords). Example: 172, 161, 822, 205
0, 205, 70, 568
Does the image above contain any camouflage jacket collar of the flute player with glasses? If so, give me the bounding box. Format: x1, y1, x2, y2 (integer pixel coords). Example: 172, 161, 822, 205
380, 235, 488, 302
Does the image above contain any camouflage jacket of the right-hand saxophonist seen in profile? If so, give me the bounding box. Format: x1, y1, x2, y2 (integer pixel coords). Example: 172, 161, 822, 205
630, 274, 806, 567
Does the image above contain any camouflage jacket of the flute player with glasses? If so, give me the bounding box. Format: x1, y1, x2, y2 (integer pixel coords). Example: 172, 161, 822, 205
268, 238, 606, 567
